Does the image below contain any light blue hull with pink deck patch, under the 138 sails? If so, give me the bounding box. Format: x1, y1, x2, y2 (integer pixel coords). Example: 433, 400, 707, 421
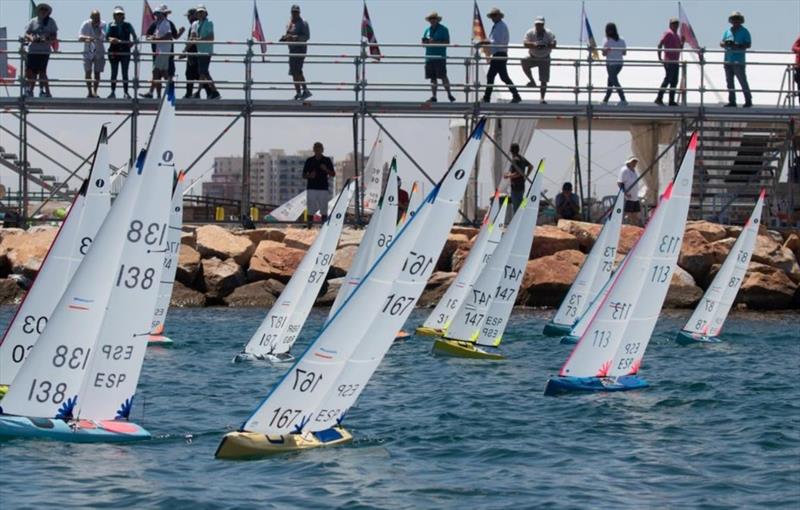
0, 415, 150, 443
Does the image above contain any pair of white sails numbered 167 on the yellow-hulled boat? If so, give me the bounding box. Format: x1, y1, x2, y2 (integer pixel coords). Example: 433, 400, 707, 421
242, 121, 484, 434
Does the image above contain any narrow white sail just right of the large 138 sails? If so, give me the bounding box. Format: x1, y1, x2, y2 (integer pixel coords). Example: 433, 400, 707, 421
150, 171, 186, 335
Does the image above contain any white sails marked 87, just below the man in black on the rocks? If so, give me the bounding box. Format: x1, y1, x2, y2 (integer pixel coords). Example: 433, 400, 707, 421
239, 182, 355, 358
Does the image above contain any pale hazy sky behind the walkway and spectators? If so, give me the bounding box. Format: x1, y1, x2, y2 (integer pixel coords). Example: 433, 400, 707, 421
0, 0, 800, 203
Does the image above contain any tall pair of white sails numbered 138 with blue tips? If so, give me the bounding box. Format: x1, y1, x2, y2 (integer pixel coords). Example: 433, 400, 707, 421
3, 90, 175, 420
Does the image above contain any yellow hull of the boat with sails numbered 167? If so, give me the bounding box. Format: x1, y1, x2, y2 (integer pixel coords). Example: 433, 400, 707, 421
214, 427, 353, 460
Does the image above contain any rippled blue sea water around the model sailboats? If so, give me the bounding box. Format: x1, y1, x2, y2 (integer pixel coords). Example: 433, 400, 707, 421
0, 308, 800, 510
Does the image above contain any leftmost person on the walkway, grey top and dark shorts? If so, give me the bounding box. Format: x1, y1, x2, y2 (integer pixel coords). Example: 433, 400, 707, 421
25, 3, 58, 97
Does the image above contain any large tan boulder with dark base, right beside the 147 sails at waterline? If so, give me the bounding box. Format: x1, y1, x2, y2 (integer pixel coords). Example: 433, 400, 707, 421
517, 255, 578, 306
